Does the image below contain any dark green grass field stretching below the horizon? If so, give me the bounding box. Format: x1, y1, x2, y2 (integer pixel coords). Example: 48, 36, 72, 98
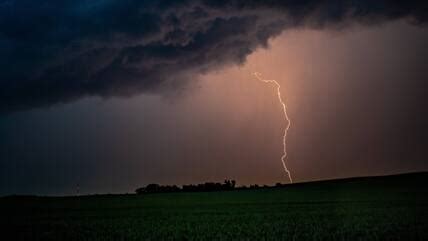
0, 173, 428, 241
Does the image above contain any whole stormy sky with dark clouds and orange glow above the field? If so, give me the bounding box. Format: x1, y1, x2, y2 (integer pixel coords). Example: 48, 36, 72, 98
0, 0, 428, 195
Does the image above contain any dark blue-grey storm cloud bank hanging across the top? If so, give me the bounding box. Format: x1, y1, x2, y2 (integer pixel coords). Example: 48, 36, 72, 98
0, 0, 428, 112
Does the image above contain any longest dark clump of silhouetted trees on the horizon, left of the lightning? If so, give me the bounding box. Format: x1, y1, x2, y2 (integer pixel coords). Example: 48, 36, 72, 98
135, 180, 236, 194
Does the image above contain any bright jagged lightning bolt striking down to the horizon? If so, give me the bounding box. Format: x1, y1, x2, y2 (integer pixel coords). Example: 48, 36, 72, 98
253, 72, 293, 183
